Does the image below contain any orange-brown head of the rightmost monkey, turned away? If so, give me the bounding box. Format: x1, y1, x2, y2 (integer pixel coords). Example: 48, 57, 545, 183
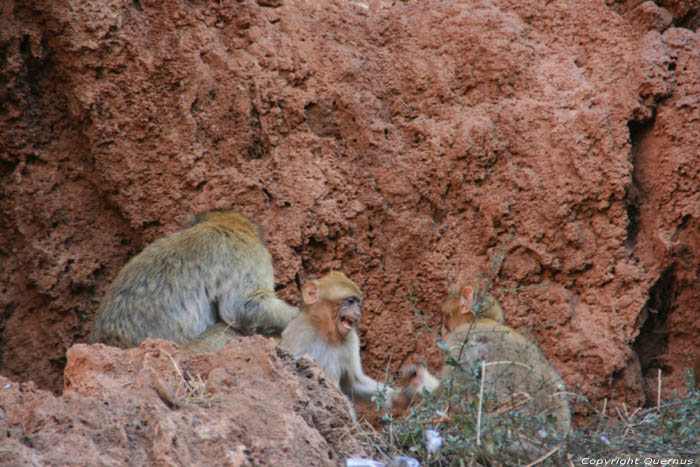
441, 285, 504, 332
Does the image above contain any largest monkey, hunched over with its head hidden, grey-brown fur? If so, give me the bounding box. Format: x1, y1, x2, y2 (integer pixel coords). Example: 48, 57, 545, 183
89, 210, 299, 348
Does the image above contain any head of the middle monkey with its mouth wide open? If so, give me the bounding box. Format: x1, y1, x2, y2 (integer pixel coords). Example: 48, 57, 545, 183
301, 271, 362, 343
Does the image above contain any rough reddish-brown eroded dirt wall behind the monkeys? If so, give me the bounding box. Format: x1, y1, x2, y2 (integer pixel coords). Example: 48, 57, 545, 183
0, 0, 700, 405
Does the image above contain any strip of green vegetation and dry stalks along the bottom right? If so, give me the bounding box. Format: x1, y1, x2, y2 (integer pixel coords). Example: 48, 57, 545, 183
383, 378, 700, 466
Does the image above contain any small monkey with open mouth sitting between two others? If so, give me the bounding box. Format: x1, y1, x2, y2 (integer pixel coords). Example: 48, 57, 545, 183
280, 271, 396, 417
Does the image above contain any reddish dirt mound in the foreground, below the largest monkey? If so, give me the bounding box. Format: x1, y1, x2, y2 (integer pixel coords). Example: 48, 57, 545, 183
0, 337, 364, 466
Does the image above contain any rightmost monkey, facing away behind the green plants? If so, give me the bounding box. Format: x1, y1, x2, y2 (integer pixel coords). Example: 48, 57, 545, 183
402, 286, 571, 435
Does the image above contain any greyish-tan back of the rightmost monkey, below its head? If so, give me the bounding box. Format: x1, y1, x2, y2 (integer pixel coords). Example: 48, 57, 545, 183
446, 319, 571, 433
